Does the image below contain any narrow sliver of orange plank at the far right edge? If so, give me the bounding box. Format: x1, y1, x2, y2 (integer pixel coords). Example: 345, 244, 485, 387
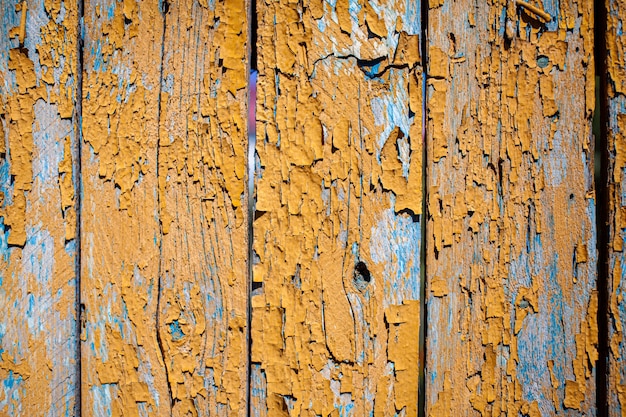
605, 0, 626, 416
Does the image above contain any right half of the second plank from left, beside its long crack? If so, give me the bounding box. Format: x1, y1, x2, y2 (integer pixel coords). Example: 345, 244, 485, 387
158, 0, 248, 416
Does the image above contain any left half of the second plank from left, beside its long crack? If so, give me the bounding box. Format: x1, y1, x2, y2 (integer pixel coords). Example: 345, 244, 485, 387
81, 0, 172, 416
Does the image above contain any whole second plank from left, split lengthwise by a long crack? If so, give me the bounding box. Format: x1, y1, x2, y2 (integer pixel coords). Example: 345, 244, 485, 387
82, 0, 248, 416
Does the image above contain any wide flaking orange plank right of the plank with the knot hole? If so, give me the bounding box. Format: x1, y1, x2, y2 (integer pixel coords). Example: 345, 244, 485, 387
426, 0, 598, 416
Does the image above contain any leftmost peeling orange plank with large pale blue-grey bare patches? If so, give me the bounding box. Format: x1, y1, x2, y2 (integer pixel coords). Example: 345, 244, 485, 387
0, 0, 78, 416
